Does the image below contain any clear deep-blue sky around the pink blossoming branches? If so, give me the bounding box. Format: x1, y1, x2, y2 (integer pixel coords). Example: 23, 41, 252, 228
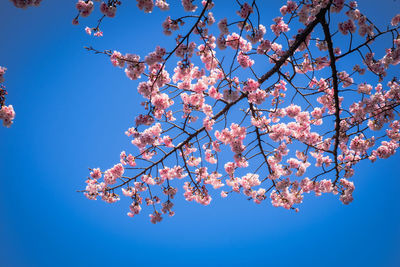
0, 0, 400, 266
